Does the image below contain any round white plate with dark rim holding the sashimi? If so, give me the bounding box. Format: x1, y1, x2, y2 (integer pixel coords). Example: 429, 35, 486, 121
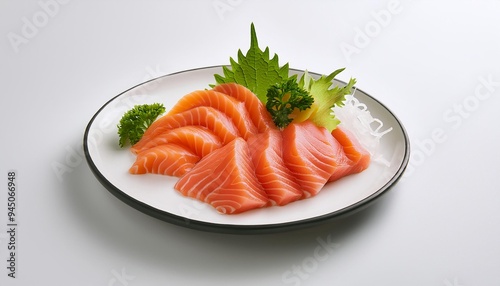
83, 66, 409, 234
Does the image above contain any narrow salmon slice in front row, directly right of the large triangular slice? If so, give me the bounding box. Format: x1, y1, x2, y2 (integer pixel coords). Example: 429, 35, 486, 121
247, 129, 303, 206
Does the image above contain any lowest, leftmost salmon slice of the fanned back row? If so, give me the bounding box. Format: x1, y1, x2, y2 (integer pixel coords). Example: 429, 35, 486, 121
129, 144, 200, 177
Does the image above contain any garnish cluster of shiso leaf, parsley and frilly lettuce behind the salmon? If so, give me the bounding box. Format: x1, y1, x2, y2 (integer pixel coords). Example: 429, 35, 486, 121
214, 23, 356, 132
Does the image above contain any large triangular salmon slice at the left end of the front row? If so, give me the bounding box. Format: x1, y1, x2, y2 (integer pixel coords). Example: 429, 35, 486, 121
174, 138, 268, 214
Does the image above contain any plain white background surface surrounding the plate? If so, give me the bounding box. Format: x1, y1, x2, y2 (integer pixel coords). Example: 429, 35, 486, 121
0, 0, 500, 286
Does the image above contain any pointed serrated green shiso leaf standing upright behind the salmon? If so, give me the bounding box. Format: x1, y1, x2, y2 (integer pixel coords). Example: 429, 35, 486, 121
214, 23, 289, 104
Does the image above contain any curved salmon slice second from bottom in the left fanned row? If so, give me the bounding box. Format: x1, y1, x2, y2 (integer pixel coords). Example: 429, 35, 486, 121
134, 125, 222, 158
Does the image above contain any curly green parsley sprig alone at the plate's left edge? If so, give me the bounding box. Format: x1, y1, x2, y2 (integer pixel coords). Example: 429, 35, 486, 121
118, 103, 165, 147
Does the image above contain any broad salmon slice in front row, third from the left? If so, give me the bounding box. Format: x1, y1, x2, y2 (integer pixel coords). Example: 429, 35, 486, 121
282, 120, 348, 198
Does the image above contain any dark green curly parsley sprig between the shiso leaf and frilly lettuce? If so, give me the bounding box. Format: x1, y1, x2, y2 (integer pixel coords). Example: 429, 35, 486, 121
266, 78, 314, 128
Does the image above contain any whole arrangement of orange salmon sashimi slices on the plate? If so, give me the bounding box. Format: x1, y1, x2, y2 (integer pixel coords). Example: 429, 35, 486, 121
125, 83, 371, 214
